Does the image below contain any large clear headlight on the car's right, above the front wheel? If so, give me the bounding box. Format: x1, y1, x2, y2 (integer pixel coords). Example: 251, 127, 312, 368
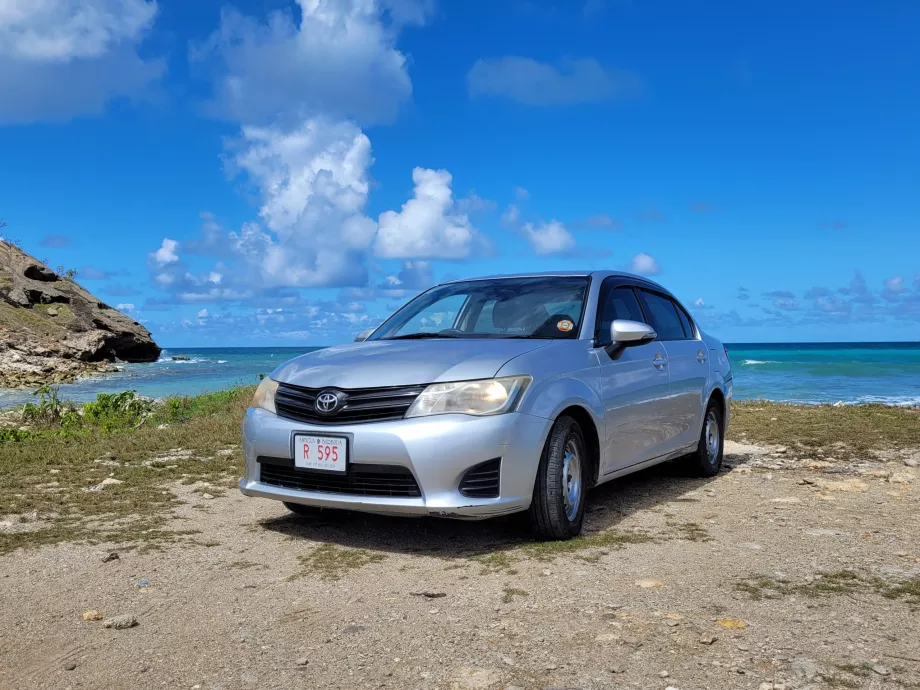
406, 376, 533, 417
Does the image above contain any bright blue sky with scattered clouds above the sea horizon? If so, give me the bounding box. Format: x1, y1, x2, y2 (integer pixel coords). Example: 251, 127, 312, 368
0, 0, 920, 347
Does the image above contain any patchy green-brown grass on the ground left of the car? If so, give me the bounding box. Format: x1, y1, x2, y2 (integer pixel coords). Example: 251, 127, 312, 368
0, 388, 252, 553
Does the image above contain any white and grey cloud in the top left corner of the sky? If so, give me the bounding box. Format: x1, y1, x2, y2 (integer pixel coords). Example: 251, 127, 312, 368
0, 0, 166, 122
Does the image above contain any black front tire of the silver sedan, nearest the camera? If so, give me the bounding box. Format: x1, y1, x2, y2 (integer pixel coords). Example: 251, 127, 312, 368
529, 416, 591, 541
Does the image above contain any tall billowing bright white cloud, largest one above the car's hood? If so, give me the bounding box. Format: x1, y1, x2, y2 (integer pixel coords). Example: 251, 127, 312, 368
231, 119, 376, 287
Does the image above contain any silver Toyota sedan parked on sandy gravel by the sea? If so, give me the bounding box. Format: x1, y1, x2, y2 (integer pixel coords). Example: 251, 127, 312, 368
240, 271, 732, 539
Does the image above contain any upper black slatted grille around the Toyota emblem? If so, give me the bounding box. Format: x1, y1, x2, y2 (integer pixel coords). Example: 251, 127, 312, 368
275, 383, 427, 424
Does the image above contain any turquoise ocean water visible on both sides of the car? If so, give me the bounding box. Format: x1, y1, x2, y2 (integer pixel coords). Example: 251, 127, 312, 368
0, 343, 920, 408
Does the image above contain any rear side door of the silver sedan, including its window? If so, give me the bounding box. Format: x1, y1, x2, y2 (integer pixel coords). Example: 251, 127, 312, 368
639, 288, 709, 450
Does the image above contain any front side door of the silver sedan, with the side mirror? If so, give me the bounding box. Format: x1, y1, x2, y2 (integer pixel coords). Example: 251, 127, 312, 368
595, 278, 670, 476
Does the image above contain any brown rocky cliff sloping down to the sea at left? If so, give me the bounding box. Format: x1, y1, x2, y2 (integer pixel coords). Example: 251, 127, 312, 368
0, 242, 160, 388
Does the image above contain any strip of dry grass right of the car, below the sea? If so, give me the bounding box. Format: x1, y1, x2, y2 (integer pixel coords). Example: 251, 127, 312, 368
729, 401, 920, 459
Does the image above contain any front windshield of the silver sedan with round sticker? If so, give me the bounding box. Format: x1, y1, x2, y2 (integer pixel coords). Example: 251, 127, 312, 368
371, 276, 588, 340
